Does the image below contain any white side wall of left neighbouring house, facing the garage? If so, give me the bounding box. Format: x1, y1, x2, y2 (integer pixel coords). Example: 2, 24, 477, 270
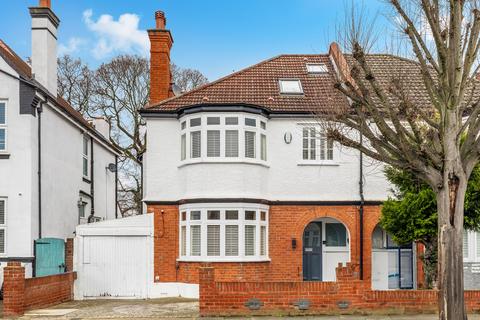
42, 106, 115, 238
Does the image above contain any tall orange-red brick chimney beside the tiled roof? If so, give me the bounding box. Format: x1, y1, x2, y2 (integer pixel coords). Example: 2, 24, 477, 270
148, 11, 174, 104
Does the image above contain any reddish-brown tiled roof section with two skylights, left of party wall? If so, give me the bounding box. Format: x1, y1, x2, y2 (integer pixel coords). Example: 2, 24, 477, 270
147, 54, 347, 112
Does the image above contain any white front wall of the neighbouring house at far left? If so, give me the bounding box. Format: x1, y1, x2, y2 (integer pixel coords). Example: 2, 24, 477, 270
0, 59, 37, 257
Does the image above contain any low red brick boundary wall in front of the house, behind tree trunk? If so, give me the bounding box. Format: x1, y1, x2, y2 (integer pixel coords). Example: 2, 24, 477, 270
200, 263, 480, 316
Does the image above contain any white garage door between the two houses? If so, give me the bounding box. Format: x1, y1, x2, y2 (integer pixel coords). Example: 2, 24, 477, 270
76, 235, 149, 298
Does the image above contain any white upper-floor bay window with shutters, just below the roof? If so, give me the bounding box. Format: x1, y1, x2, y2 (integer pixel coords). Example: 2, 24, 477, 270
180, 114, 267, 162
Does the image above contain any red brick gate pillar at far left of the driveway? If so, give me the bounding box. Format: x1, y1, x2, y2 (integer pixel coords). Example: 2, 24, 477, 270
3, 261, 25, 316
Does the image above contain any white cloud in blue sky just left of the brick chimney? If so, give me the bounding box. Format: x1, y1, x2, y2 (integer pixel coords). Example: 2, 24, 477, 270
83, 9, 150, 59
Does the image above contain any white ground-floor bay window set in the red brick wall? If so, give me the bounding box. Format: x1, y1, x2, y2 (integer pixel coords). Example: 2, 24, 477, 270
179, 204, 268, 262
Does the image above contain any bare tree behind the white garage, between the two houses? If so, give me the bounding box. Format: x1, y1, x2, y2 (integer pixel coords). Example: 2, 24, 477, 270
59, 55, 206, 216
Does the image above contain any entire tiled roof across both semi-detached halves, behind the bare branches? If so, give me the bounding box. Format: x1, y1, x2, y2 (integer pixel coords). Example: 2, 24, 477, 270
146, 50, 480, 113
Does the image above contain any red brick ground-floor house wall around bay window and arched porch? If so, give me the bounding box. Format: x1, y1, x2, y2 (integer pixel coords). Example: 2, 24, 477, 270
148, 205, 388, 283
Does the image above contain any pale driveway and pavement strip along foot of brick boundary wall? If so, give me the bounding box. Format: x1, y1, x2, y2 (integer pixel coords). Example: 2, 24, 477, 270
3, 298, 480, 320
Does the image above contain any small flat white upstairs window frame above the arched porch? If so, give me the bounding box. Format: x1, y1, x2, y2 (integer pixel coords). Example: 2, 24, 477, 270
298, 123, 339, 166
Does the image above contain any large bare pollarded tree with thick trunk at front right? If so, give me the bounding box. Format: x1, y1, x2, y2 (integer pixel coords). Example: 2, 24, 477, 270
327, 0, 480, 319
